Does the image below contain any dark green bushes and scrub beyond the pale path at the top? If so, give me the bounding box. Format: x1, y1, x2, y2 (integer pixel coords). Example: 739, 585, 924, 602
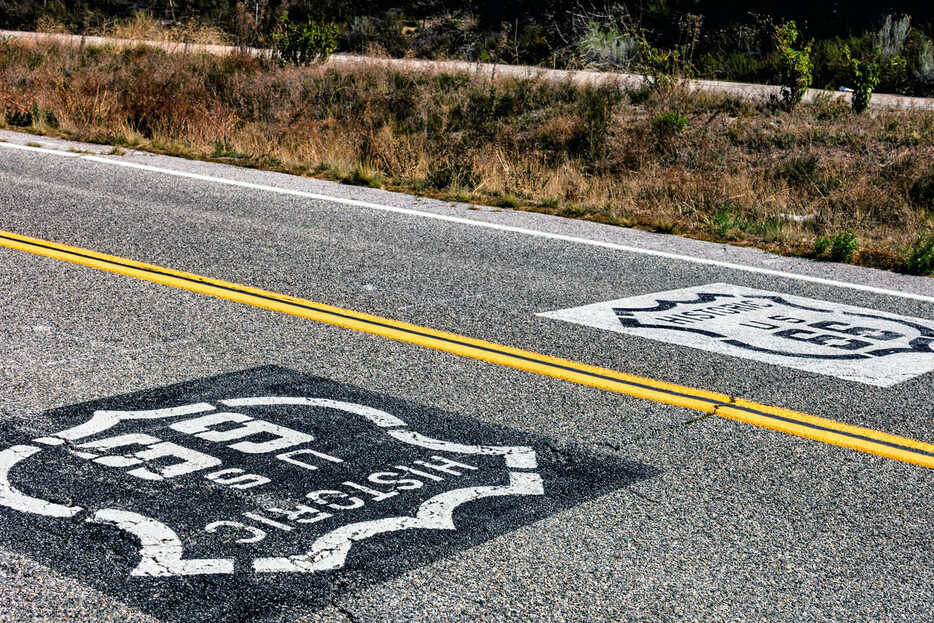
0, 0, 934, 101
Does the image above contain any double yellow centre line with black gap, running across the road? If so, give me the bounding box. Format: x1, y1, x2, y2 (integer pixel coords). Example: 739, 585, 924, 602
0, 231, 934, 468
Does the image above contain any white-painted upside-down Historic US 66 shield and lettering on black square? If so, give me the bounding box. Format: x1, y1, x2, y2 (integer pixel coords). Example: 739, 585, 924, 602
0, 396, 544, 577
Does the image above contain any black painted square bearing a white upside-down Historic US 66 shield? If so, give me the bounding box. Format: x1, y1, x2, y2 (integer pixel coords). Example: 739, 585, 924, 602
0, 367, 655, 620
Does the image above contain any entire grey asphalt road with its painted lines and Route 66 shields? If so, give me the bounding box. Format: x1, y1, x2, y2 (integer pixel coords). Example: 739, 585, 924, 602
0, 132, 934, 622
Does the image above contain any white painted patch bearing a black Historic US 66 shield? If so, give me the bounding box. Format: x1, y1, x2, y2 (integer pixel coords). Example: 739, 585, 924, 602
538, 283, 934, 387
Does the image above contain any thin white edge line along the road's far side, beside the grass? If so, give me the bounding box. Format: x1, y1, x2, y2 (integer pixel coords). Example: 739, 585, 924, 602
0, 141, 934, 303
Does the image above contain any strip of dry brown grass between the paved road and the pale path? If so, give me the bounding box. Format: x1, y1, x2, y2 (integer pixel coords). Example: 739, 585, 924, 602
0, 42, 934, 268
